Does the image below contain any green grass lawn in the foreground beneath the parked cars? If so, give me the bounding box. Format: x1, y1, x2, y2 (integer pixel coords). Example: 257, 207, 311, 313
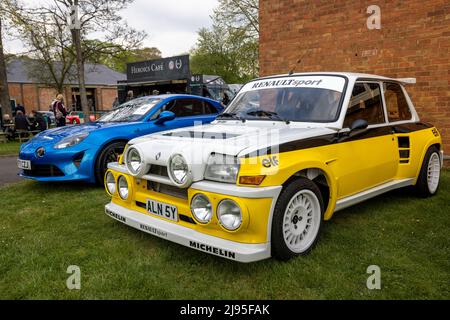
0, 171, 450, 299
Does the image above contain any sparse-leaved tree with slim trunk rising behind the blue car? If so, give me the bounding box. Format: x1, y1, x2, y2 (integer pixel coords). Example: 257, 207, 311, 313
2, 0, 146, 118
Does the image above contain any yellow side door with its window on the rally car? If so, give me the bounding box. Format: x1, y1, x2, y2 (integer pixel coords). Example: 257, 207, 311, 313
334, 82, 399, 199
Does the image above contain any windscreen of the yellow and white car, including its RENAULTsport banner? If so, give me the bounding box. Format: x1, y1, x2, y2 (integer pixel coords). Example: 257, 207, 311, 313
221, 76, 346, 122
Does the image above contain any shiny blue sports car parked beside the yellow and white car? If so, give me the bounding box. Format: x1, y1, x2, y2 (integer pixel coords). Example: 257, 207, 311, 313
17, 94, 223, 183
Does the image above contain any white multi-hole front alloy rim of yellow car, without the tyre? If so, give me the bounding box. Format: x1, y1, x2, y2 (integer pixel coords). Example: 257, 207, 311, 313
283, 189, 322, 253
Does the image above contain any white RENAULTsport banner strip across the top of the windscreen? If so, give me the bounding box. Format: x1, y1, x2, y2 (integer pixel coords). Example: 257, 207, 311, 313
241, 76, 345, 92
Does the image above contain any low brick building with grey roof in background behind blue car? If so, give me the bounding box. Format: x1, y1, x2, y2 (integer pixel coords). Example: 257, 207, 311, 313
6, 59, 126, 112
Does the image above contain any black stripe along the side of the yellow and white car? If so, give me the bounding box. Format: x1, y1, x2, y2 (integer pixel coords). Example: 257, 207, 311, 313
242, 122, 433, 158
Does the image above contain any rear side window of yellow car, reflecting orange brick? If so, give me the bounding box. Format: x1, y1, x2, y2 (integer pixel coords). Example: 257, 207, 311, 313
384, 82, 412, 122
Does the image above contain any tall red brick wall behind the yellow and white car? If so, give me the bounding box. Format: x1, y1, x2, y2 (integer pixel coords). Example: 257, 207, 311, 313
260, 0, 450, 155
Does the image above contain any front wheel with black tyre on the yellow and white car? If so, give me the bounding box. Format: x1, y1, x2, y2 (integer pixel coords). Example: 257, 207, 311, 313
271, 178, 324, 261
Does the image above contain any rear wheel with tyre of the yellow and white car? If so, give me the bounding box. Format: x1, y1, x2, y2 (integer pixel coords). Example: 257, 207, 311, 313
415, 146, 441, 198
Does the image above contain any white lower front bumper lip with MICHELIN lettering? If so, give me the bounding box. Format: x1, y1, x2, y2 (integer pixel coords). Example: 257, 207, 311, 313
105, 202, 270, 263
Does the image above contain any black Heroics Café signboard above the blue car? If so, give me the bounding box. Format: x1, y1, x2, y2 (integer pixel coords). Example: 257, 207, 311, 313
127, 55, 190, 82
